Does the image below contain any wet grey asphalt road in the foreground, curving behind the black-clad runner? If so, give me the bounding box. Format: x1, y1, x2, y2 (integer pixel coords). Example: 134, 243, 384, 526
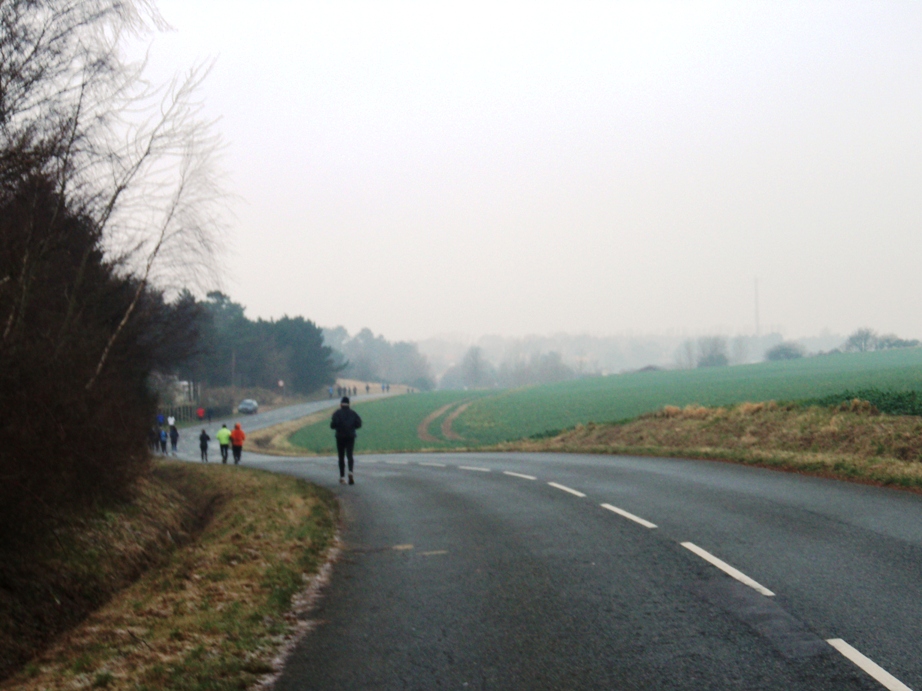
174, 410, 922, 690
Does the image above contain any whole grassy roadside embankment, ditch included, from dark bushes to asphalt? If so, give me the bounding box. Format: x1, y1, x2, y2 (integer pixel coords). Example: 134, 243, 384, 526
0, 462, 336, 690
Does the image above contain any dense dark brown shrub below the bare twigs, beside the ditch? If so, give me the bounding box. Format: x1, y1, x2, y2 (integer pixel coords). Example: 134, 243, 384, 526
0, 178, 195, 546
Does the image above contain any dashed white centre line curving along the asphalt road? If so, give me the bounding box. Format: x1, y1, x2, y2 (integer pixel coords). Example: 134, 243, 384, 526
352, 454, 912, 691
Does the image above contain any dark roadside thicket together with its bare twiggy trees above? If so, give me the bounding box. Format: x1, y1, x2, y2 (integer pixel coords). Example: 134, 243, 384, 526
0, 0, 219, 546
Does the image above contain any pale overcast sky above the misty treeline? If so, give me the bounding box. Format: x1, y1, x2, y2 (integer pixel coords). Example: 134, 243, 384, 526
140, 0, 922, 339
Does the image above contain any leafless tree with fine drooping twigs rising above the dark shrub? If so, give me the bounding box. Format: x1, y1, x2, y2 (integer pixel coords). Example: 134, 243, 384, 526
0, 0, 222, 389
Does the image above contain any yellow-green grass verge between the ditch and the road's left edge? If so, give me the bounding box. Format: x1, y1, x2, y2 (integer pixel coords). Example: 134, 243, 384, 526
0, 462, 336, 690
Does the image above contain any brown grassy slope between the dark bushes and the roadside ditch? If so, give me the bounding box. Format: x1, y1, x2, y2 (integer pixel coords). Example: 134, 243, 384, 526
0, 466, 205, 678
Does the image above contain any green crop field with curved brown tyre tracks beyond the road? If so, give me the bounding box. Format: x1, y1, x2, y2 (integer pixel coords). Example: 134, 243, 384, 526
292, 348, 922, 453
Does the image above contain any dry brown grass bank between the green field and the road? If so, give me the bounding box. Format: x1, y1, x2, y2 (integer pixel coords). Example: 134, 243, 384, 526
501, 400, 922, 489
